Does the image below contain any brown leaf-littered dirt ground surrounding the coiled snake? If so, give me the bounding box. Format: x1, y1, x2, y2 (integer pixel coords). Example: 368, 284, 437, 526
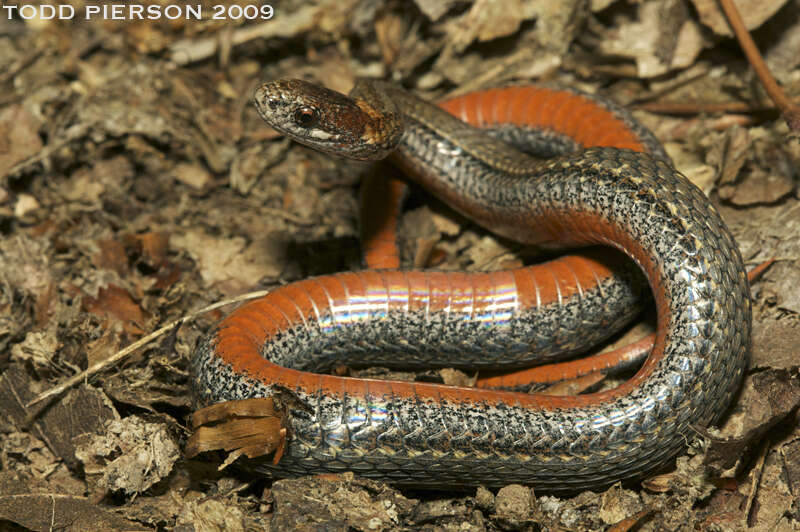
0, 0, 800, 531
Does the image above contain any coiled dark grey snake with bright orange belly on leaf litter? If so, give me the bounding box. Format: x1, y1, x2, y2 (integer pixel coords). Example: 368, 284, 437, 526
191, 79, 752, 494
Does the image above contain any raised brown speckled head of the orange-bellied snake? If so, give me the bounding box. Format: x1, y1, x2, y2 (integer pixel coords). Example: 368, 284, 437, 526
254, 79, 402, 161
